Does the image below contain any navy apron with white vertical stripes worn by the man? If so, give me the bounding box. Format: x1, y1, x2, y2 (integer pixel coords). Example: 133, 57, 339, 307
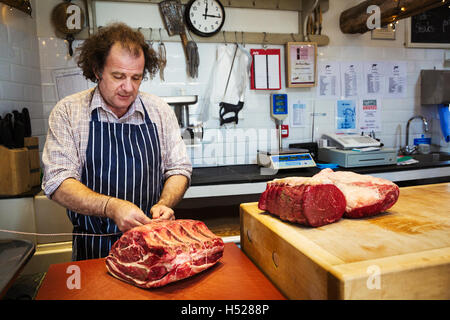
67, 100, 163, 261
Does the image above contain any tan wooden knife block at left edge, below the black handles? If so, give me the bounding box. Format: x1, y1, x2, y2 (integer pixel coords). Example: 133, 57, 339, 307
0, 145, 31, 196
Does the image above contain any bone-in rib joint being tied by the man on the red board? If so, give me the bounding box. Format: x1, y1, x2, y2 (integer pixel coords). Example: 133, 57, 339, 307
106, 219, 224, 288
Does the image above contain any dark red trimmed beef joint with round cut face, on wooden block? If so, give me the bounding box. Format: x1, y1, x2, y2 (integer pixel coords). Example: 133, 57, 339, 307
258, 177, 346, 227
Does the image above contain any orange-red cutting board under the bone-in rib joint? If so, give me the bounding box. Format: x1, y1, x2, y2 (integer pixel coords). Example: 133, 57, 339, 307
36, 243, 286, 300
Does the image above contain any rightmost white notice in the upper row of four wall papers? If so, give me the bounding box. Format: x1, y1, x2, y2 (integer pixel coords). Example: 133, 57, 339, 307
385, 61, 406, 98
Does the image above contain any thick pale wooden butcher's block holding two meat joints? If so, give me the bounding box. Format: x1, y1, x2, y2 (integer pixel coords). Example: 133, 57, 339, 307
241, 183, 450, 299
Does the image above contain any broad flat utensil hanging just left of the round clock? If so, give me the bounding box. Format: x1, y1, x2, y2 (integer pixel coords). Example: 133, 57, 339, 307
158, 0, 189, 67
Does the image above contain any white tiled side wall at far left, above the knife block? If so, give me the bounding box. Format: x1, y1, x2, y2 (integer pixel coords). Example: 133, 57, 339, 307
0, 1, 47, 154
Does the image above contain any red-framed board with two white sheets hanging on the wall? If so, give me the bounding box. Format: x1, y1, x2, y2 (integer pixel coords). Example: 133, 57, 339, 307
250, 49, 281, 90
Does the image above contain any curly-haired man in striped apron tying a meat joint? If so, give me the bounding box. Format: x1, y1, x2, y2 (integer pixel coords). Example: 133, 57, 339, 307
42, 23, 192, 260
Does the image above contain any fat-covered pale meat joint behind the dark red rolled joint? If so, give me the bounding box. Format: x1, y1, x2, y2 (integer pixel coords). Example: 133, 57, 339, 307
314, 168, 400, 218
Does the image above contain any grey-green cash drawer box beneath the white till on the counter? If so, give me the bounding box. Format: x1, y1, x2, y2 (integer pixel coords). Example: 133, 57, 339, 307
317, 148, 397, 168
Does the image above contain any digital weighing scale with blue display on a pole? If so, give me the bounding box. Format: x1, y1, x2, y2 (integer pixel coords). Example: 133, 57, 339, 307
257, 94, 316, 170
